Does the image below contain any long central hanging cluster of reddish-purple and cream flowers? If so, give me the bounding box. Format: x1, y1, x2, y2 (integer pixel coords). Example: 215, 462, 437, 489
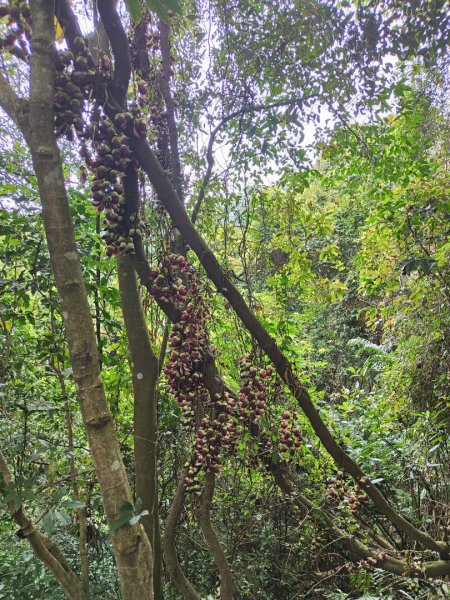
149, 253, 244, 492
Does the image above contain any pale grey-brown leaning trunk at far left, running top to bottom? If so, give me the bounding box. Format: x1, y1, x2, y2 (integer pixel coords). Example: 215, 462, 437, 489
24, 0, 153, 600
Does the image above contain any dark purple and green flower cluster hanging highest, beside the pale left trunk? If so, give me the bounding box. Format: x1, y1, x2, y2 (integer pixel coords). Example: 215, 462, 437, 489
50, 37, 146, 256
